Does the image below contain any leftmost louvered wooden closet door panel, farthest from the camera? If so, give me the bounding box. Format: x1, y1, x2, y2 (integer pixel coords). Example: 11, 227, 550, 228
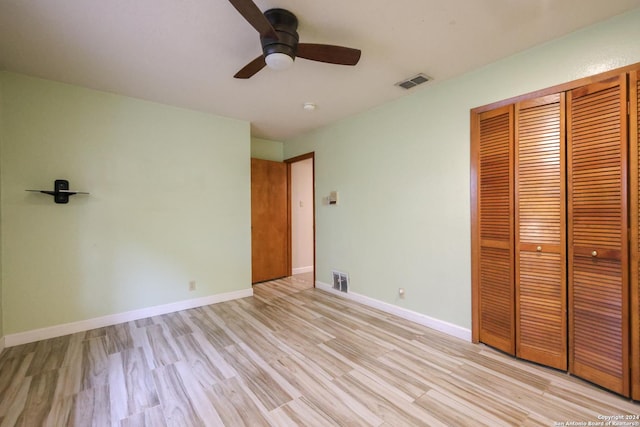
476, 106, 515, 354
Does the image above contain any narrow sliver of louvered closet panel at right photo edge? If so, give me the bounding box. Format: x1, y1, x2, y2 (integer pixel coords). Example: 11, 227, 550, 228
629, 71, 640, 400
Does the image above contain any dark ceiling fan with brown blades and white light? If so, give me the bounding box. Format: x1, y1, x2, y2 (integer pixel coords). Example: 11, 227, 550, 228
229, 0, 361, 79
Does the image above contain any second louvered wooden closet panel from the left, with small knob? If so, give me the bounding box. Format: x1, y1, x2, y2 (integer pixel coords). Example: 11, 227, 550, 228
515, 93, 567, 370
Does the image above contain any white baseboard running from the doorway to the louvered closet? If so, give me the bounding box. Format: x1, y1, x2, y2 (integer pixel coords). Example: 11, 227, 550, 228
316, 281, 471, 342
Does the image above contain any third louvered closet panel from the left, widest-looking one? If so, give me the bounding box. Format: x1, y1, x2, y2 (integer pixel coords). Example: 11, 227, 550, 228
567, 75, 629, 396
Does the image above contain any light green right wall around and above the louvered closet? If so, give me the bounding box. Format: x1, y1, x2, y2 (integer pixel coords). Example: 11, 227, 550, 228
284, 9, 640, 328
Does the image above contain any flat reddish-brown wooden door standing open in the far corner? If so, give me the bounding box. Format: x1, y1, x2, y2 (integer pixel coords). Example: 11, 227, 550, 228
251, 159, 290, 283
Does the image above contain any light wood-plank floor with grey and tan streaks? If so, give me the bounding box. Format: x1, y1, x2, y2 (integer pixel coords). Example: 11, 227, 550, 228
0, 277, 640, 427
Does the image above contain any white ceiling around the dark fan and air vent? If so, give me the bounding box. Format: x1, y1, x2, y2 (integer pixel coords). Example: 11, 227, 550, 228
0, 0, 640, 140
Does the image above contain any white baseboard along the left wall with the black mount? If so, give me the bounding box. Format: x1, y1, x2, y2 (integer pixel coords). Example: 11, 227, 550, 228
0, 288, 253, 351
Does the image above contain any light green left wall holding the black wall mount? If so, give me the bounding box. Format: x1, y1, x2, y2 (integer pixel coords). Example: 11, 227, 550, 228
0, 73, 251, 335
